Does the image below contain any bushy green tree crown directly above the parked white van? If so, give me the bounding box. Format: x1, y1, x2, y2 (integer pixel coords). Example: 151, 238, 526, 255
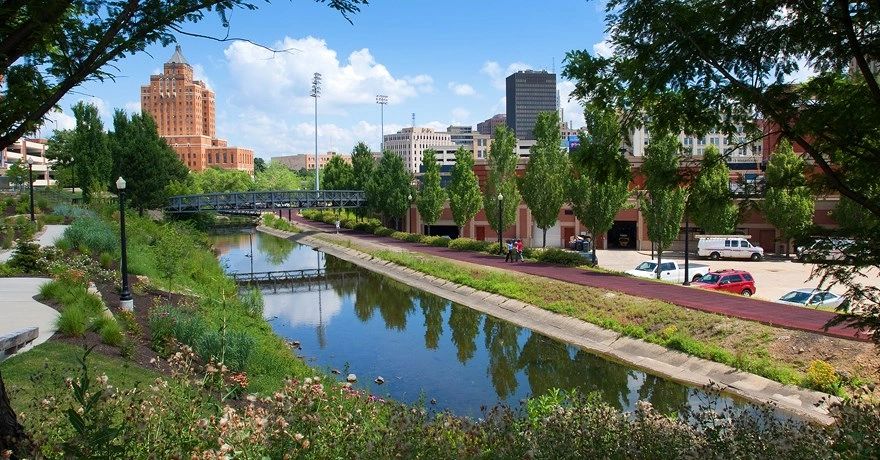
687, 145, 739, 235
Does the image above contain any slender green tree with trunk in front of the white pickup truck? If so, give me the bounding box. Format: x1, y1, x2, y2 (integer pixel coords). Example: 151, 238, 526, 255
641, 131, 686, 279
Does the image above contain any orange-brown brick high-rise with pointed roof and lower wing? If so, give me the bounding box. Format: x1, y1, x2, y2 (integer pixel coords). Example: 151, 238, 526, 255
141, 45, 254, 174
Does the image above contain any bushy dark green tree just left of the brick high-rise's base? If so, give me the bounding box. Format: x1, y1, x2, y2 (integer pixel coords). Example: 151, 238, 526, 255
110, 110, 189, 215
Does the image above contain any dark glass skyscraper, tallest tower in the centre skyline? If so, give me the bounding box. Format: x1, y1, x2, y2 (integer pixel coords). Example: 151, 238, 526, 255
507, 70, 556, 140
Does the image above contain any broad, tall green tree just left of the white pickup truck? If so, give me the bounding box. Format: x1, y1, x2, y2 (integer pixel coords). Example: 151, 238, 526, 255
568, 105, 632, 260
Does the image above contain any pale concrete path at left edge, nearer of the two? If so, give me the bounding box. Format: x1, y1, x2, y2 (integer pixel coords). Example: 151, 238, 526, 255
0, 278, 58, 353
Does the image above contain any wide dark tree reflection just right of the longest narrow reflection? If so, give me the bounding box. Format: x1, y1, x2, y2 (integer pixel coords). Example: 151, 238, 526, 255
518, 333, 574, 396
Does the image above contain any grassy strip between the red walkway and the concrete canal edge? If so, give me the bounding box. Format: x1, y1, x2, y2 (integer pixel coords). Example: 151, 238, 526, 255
319, 235, 863, 395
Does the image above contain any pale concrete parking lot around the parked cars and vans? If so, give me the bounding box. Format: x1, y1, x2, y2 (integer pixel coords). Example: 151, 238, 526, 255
596, 250, 880, 301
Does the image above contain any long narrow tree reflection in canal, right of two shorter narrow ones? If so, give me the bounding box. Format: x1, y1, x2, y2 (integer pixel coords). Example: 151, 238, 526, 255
483, 316, 521, 399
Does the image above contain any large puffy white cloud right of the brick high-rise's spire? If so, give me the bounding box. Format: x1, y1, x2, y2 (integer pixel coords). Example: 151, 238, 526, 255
224, 36, 433, 114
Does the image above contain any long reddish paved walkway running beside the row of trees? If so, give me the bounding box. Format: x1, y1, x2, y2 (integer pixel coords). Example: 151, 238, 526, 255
293, 216, 870, 342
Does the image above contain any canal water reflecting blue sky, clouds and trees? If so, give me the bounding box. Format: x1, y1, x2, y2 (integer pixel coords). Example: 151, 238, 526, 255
212, 231, 764, 417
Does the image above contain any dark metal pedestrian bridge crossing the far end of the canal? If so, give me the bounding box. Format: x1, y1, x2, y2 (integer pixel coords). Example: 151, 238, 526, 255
165, 190, 366, 214
